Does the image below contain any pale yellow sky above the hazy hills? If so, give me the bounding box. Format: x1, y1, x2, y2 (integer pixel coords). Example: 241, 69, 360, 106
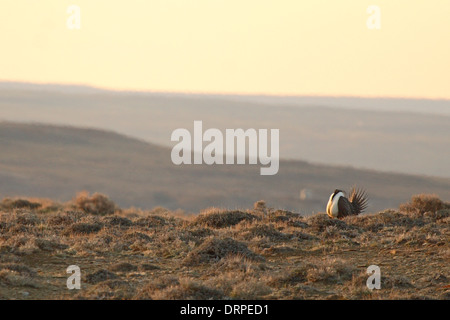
0, 0, 450, 99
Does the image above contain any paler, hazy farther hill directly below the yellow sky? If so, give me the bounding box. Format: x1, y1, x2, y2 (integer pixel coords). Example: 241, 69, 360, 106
0, 82, 450, 178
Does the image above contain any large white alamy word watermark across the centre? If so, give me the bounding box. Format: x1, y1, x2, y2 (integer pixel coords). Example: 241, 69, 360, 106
171, 121, 280, 175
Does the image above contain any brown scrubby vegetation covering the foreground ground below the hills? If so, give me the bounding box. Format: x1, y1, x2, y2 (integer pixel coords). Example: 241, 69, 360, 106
0, 194, 450, 299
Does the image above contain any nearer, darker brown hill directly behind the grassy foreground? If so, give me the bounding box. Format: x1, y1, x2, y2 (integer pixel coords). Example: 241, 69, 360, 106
0, 122, 450, 214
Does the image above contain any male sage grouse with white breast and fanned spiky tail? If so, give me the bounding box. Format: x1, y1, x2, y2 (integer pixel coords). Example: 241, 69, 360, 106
327, 188, 367, 219
